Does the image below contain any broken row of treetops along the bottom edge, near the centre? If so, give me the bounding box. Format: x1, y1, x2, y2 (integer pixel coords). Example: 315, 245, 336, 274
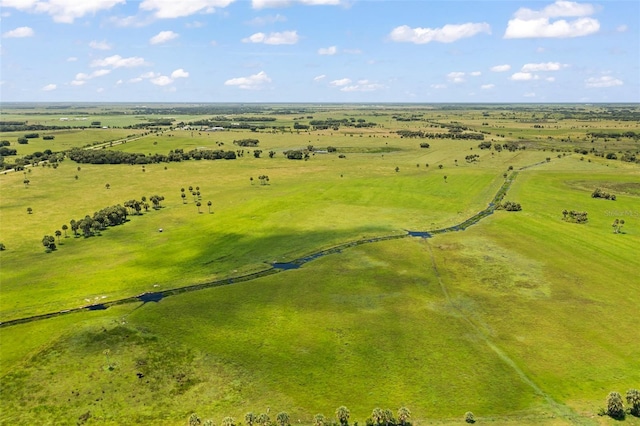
187, 406, 412, 426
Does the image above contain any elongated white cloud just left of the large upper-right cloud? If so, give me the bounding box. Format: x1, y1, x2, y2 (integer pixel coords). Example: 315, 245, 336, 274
389, 22, 491, 44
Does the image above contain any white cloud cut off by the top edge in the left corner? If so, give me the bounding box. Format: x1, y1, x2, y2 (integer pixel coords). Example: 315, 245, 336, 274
2, 0, 125, 24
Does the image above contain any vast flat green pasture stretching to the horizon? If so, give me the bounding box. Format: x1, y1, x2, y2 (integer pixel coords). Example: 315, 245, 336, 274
0, 104, 640, 425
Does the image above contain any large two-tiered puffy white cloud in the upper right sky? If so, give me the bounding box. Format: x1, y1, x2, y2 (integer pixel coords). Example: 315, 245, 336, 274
504, 0, 600, 38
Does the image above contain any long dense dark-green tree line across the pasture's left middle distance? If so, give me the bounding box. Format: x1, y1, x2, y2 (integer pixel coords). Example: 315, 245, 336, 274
67, 148, 236, 164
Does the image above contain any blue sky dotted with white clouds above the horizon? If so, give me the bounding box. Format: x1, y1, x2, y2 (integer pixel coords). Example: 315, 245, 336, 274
0, 0, 640, 103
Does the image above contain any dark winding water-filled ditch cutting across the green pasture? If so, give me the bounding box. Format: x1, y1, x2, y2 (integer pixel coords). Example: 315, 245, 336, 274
0, 163, 543, 328
